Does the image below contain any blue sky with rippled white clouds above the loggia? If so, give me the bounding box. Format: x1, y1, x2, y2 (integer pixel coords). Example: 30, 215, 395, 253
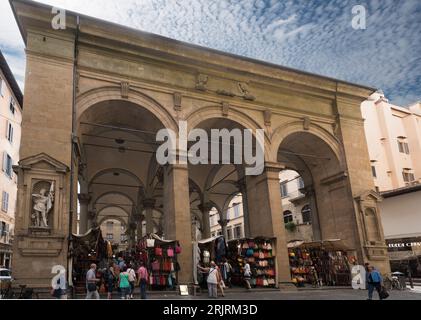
0, 0, 421, 106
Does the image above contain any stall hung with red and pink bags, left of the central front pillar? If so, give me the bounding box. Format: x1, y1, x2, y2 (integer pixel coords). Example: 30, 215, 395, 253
135, 234, 181, 291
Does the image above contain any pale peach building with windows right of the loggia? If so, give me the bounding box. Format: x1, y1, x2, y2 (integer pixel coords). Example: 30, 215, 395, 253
361, 92, 421, 191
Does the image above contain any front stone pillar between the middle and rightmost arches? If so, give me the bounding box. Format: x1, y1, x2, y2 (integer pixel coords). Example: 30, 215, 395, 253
247, 163, 291, 287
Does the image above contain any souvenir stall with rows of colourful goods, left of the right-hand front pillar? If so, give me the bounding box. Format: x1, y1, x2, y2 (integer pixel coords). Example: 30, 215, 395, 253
228, 237, 276, 287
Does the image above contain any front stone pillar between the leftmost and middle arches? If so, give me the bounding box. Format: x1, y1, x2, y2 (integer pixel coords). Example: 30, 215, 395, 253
164, 164, 193, 284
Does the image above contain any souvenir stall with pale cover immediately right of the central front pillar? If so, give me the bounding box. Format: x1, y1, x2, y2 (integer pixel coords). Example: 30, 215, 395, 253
193, 236, 228, 288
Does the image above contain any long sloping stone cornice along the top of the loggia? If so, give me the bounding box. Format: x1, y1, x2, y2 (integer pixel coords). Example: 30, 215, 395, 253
11, 0, 375, 101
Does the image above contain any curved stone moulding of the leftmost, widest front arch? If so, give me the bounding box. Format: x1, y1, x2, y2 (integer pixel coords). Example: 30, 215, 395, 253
76, 86, 178, 132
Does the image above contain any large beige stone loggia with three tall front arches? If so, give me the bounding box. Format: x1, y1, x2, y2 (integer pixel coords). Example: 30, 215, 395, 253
11, 0, 389, 288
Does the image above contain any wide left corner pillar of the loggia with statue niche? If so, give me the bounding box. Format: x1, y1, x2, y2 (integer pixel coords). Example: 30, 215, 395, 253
12, 8, 77, 290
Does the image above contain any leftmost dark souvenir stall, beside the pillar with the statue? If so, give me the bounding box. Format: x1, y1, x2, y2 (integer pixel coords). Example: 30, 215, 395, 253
69, 227, 109, 294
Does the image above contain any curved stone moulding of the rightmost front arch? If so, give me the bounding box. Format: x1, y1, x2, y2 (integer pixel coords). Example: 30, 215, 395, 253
269, 121, 343, 165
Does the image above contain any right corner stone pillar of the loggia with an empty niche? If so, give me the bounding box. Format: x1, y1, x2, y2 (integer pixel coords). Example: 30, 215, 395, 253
334, 95, 390, 273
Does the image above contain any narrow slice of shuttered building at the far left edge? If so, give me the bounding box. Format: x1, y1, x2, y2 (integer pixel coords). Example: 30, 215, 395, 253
0, 52, 23, 268
